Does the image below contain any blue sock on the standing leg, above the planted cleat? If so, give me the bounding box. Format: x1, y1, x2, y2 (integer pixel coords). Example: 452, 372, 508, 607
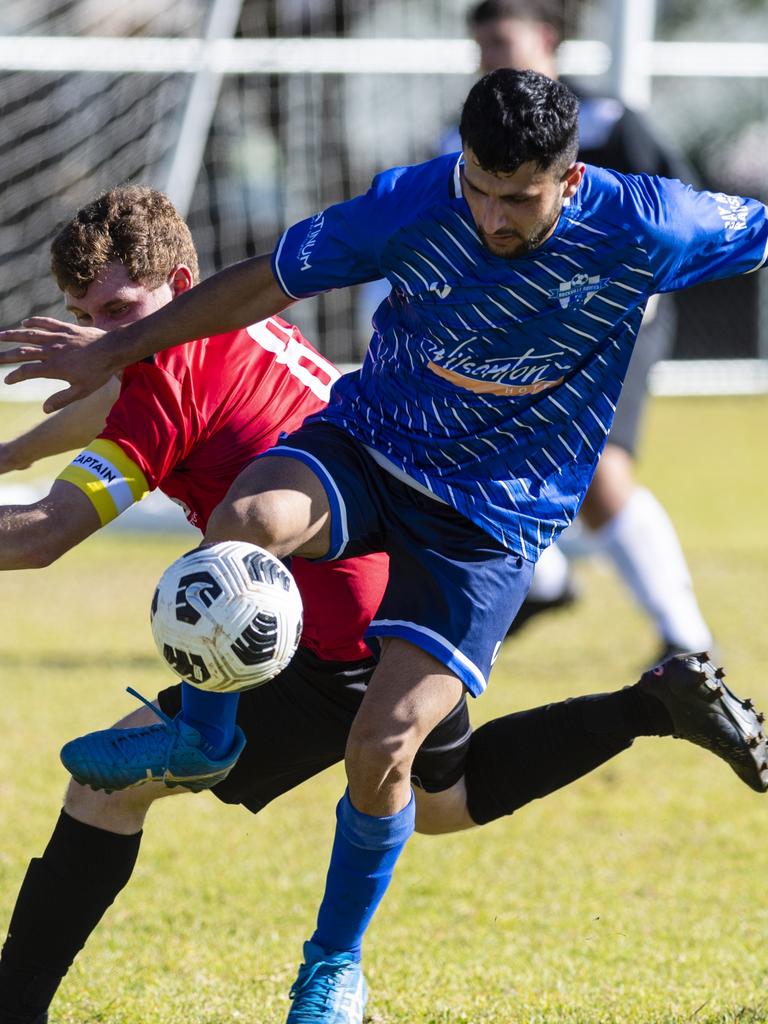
312, 791, 416, 959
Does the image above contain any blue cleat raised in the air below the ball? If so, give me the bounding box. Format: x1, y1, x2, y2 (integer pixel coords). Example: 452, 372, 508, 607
60, 687, 246, 793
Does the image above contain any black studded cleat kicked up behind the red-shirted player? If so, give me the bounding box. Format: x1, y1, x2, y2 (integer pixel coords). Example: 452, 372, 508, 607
639, 653, 768, 793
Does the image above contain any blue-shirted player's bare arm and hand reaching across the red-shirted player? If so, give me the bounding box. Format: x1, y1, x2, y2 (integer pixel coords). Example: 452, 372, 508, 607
0, 255, 294, 413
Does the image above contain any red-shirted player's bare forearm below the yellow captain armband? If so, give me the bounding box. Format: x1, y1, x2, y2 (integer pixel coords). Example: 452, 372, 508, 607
0, 480, 101, 569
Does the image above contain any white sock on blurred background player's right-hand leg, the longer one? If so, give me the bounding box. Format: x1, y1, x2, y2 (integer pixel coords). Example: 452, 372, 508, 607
595, 487, 712, 650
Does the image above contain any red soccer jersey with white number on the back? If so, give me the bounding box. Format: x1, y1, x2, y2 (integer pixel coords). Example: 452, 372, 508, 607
100, 316, 388, 660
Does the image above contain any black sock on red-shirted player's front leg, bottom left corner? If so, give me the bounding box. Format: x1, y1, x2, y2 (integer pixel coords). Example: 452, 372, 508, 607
0, 811, 141, 1024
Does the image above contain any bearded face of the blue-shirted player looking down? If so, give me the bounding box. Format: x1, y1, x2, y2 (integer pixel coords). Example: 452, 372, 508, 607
462, 146, 584, 259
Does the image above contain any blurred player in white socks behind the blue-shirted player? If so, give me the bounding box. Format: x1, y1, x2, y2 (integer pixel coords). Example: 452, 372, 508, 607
450, 0, 712, 662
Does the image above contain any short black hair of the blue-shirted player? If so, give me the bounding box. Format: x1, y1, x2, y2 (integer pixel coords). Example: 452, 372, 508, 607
459, 68, 579, 174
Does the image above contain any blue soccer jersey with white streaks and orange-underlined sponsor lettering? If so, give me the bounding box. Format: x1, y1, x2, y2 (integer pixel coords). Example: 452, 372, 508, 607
272, 155, 768, 560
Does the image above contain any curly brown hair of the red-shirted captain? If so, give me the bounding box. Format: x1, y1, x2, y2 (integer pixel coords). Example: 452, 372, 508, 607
50, 185, 200, 297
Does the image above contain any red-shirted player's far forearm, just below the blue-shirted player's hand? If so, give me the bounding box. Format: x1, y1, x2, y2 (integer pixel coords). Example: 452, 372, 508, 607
0, 377, 120, 473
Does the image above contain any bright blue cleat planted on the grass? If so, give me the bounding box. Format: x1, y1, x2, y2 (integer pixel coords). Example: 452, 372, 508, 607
286, 942, 368, 1024
